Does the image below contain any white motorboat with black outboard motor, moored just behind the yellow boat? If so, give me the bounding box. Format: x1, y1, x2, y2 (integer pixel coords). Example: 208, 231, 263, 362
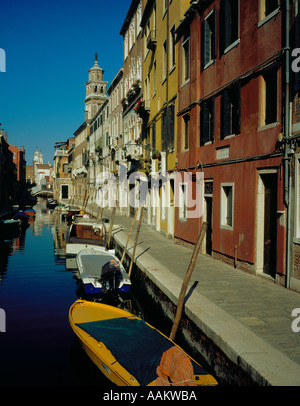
76, 247, 131, 297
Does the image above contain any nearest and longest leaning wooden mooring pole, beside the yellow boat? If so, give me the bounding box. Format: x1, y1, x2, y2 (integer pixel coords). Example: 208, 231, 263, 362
169, 223, 207, 341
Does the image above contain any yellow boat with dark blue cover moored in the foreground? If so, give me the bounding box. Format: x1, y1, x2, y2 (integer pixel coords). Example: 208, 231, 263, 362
69, 300, 217, 386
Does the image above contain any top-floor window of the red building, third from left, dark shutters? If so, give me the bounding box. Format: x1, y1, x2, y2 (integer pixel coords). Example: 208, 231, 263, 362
220, 0, 239, 55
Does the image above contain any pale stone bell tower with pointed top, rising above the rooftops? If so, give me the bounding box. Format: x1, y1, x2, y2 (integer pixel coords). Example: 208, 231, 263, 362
84, 53, 108, 121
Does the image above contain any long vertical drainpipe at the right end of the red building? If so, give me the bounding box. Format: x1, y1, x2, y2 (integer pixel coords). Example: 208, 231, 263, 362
283, 0, 292, 289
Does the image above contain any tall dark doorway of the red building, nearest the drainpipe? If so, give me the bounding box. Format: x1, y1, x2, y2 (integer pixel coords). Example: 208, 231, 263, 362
262, 174, 277, 278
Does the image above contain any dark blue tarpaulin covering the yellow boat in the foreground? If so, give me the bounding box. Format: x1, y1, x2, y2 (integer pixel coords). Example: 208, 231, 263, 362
77, 317, 207, 386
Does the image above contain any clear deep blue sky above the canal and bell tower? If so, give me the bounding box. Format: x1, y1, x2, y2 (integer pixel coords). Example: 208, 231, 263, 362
0, 0, 131, 165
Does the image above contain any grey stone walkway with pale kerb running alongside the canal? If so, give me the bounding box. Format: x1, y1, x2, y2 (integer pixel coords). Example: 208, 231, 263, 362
92, 209, 300, 386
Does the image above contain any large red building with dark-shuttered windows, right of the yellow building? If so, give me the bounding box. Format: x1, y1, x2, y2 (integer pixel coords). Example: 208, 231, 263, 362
175, 0, 286, 284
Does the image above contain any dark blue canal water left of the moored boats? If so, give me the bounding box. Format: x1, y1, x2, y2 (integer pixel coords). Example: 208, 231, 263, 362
0, 201, 117, 391
